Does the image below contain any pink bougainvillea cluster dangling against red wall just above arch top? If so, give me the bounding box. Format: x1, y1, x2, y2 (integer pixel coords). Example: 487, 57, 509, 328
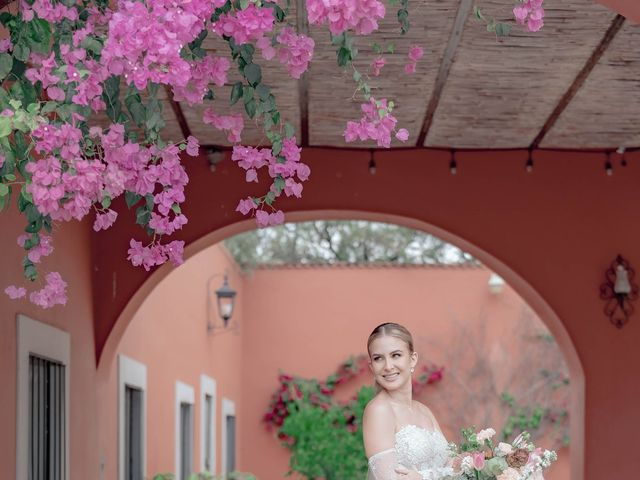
231, 137, 311, 227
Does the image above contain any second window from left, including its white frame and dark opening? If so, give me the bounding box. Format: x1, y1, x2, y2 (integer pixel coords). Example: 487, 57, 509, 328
118, 355, 147, 480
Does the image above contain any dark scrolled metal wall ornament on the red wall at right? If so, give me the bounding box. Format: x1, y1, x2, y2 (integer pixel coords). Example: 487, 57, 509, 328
600, 255, 639, 328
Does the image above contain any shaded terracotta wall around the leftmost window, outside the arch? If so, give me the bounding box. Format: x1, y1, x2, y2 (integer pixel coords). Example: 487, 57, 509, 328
0, 208, 101, 479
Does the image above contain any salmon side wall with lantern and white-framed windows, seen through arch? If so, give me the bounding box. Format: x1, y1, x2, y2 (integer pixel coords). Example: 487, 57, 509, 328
100, 247, 246, 479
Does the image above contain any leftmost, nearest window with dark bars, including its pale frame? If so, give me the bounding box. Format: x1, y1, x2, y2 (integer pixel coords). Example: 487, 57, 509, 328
16, 315, 70, 480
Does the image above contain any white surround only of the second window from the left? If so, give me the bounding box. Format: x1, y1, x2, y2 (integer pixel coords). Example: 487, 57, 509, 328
118, 354, 147, 480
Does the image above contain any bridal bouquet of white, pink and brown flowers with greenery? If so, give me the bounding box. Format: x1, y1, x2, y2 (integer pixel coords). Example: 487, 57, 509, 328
451, 428, 558, 480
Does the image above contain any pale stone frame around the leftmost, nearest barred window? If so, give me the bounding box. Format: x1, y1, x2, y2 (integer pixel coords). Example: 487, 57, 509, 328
16, 314, 71, 480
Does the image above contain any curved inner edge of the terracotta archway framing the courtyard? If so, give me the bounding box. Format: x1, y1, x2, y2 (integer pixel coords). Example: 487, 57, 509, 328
98, 210, 585, 480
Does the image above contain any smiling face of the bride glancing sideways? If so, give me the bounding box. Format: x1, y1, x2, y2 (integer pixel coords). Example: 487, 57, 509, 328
369, 335, 418, 390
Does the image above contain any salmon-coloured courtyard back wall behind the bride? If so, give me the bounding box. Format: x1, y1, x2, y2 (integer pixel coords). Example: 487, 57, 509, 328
242, 268, 569, 480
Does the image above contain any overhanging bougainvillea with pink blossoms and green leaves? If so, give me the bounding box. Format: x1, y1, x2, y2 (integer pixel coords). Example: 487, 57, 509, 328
0, 0, 543, 308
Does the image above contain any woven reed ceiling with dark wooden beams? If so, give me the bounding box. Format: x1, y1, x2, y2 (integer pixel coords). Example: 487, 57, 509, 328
164, 0, 640, 149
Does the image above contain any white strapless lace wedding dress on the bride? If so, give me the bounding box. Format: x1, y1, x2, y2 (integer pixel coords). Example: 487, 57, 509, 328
367, 425, 453, 480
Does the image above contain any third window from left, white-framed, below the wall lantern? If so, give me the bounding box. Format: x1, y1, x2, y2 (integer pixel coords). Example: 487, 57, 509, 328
175, 382, 195, 480
